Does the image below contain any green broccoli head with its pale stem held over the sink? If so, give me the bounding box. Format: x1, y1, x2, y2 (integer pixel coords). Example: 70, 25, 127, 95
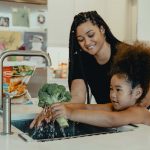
38, 83, 71, 128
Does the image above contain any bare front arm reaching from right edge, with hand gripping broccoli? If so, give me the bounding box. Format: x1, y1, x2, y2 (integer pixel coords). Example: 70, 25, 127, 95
52, 106, 150, 127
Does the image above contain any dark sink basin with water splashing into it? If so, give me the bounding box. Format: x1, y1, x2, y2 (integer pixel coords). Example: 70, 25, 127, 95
12, 119, 136, 142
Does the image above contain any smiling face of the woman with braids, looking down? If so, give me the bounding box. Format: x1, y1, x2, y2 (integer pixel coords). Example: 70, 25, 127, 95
77, 21, 105, 55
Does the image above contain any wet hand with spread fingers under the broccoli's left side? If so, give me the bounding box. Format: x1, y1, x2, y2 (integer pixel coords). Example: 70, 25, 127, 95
30, 107, 52, 129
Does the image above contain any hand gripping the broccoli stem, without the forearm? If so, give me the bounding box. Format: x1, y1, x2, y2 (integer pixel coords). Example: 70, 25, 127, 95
51, 103, 72, 120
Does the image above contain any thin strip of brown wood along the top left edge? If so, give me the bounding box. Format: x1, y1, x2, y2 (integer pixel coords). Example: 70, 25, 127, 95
0, 0, 47, 5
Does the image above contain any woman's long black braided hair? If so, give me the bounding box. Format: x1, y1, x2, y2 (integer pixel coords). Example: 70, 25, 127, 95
68, 11, 119, 103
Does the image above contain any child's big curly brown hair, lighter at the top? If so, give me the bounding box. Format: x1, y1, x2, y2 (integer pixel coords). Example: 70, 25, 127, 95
111, 42, 150, 102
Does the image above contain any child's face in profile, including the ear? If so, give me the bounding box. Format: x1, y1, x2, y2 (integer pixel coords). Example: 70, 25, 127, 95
110, 75, 137, 110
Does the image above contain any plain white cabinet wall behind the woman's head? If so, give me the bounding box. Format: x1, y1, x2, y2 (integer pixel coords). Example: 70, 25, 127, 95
48, 0, 136, 47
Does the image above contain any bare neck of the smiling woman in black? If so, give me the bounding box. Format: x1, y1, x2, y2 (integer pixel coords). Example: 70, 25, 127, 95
94, 42, 111, 65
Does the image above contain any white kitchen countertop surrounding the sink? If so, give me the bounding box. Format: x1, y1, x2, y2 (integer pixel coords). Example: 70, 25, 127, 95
0, 99, 150, 150
